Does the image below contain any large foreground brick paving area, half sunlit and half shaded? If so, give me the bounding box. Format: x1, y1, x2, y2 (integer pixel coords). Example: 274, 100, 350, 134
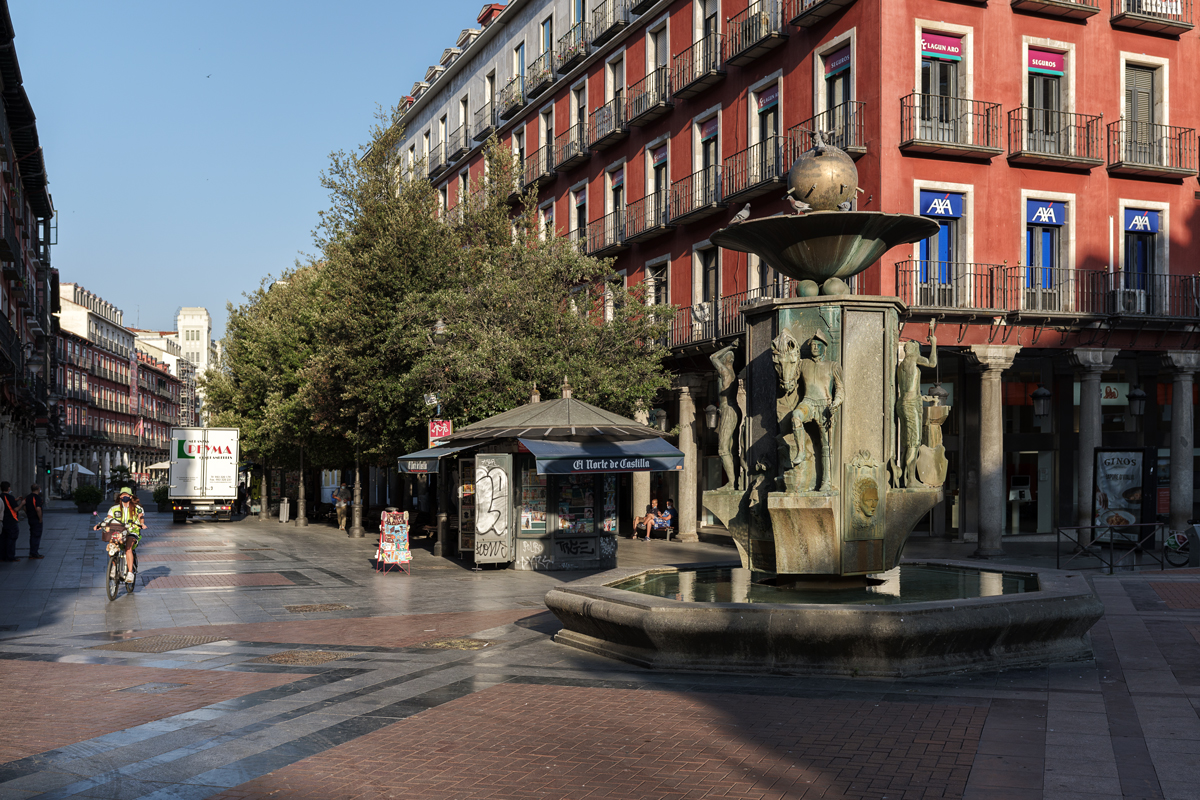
214, 684, 988, 800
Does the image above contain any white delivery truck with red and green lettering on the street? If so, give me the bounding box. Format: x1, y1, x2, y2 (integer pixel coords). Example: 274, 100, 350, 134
167, 428, 239, 522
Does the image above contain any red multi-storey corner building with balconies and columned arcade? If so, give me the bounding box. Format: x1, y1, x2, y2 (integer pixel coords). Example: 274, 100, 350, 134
401, 0, 1200, 539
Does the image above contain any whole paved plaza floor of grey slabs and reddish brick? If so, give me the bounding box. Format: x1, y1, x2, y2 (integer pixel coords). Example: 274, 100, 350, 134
0, 510, 1200, 800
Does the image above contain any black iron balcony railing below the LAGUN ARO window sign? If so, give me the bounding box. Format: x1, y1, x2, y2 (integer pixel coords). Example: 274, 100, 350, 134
900, 92, 1003, 158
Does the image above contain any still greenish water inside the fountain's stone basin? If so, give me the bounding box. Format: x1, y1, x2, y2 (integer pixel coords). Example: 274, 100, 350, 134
608, 564, 1038, 606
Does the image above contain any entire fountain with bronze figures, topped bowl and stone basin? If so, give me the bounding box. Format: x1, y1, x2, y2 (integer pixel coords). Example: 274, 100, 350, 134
546, 134, 1103, 675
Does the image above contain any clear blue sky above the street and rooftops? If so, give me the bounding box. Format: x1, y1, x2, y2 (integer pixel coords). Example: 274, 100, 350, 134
8, 0, 484, 337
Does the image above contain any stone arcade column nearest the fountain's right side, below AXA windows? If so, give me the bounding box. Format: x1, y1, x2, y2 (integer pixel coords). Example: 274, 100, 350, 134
971, 344, 1021, 558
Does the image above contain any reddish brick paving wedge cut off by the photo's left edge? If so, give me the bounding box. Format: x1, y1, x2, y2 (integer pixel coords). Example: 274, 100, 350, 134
0, 661, 305, 763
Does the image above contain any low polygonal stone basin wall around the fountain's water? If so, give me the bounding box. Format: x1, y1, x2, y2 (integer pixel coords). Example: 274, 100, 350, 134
546, 561, 1104, 678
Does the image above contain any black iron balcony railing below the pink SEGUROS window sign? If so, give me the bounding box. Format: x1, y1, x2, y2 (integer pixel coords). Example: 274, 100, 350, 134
1008, 107, 1104, 168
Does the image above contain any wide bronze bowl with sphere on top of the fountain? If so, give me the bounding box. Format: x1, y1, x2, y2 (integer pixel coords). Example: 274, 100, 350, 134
712, 142, 937, 294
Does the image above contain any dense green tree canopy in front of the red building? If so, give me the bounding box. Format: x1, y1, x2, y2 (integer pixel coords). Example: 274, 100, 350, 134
204, 110, 671, 463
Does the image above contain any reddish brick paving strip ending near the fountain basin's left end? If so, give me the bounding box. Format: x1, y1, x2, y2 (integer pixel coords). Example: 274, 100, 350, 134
130, 608, 545, 648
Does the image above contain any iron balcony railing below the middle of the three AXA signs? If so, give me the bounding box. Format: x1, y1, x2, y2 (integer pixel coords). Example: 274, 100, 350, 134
996, 265, 1109, 314
